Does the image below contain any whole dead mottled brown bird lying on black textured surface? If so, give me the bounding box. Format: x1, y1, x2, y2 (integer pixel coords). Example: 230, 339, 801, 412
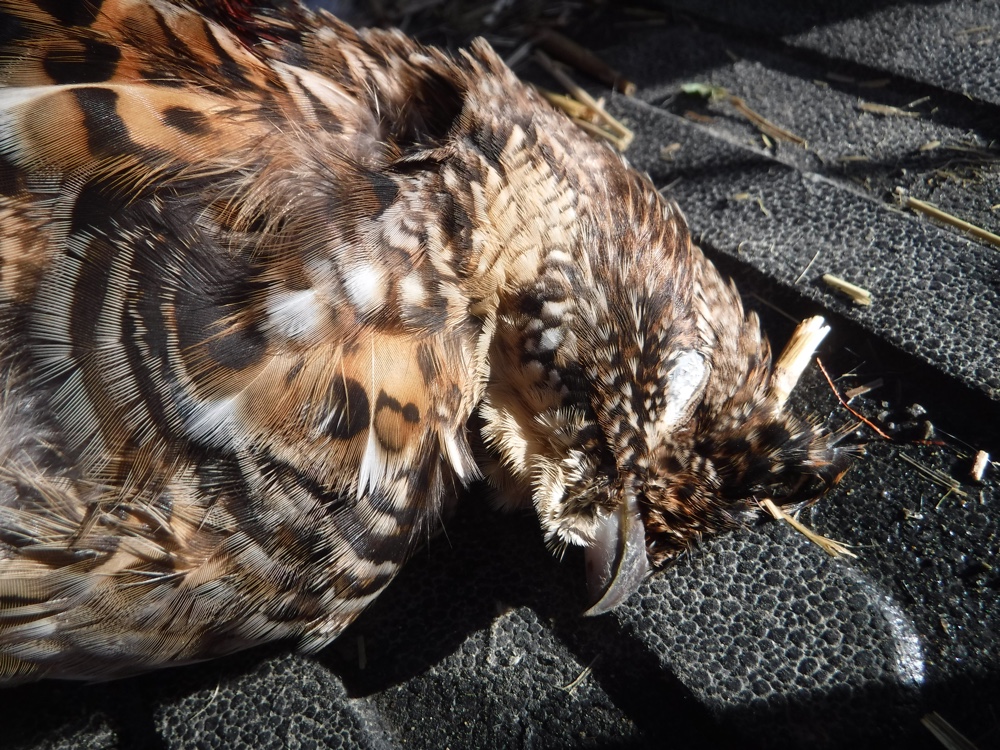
0, 0, 843, 682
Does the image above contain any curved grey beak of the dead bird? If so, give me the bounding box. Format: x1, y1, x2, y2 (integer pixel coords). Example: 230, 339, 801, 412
584, 492, 650, 615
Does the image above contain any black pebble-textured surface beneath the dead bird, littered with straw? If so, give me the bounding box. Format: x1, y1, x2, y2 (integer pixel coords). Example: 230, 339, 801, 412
7, 0, 1000, 749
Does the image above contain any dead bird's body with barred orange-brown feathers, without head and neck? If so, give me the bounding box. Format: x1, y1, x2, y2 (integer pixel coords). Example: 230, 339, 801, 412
0, 0, 482, 682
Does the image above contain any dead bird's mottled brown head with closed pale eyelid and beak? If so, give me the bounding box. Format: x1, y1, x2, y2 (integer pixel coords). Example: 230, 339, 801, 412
481, 154, 851, 614
